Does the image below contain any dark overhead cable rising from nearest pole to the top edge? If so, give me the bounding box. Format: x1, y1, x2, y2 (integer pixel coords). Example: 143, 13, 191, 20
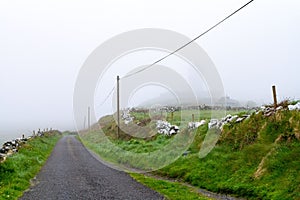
122, 0, 254, 78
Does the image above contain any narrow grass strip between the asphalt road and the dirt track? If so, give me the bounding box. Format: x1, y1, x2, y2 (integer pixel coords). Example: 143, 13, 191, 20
130, 174, 209, 200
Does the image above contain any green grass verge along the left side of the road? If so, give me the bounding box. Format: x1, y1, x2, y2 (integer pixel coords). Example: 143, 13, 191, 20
0, 133, 61, 199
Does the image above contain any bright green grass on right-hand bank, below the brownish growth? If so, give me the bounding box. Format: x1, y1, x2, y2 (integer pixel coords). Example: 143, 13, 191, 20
156, 143, 300, 200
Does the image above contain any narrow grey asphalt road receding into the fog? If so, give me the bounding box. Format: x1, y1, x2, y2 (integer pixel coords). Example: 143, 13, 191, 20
20, 136, 164, 200
